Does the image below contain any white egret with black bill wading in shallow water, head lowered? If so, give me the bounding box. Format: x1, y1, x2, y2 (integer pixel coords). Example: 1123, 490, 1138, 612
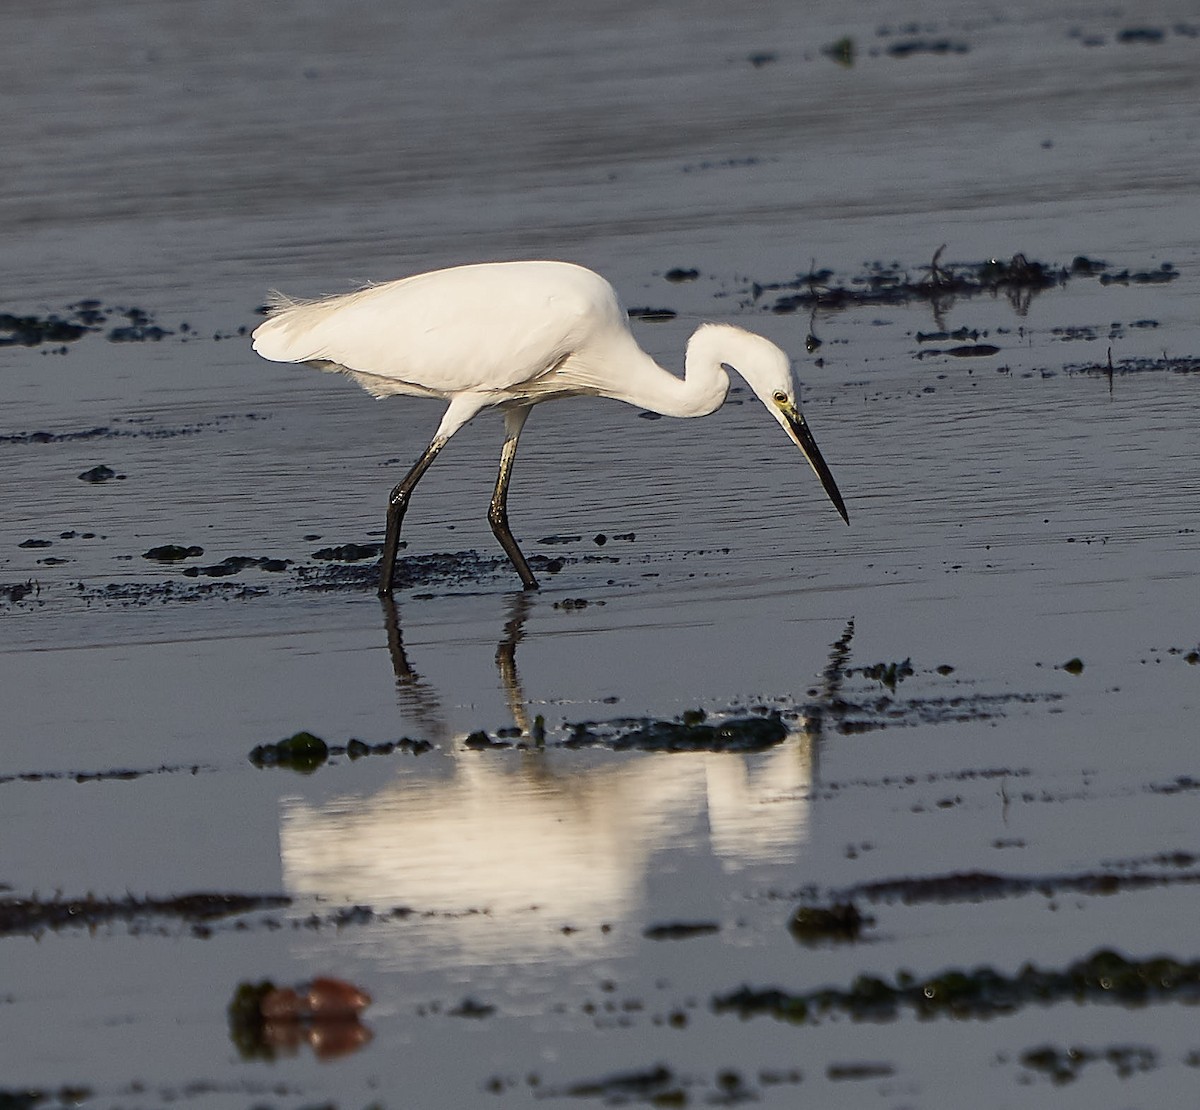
253, 262, 850, 596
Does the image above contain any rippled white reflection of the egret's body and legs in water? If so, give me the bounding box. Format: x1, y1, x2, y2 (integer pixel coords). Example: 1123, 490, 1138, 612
281, 594, 830, 960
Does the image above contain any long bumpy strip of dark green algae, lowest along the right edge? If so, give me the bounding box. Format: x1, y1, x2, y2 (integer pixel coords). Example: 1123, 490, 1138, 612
713, 948, 1200, 1025
